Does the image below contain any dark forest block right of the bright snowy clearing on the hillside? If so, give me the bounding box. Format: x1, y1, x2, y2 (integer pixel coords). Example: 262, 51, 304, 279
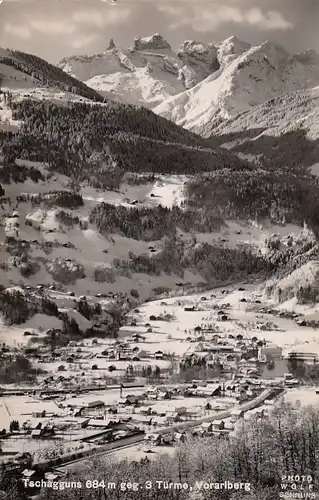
185, 168, 319, 230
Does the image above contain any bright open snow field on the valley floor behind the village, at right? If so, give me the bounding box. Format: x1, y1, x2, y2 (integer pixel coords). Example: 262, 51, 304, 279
132, 284, 319, 355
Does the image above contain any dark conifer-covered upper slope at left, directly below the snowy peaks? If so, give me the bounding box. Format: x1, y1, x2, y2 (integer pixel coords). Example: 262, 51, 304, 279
3, 96, 250, 185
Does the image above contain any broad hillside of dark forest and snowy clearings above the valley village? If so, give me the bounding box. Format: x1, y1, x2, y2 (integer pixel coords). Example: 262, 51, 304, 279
0, 81, 319, 304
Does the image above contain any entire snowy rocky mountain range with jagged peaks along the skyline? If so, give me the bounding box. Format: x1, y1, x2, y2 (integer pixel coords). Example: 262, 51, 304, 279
59, 33, 319, 136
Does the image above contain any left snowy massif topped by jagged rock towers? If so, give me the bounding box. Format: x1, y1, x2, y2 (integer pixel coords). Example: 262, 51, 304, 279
58, 34, 219, 108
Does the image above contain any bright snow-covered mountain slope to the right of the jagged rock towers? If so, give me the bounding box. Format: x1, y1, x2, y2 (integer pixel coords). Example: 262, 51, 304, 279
154, 41, 319, 136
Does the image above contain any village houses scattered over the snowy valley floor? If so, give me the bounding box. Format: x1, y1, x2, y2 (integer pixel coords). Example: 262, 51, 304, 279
0, 292, 310, 466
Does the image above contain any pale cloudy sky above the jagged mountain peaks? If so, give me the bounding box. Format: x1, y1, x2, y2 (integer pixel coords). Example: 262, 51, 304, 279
0, 0, 319, 64
